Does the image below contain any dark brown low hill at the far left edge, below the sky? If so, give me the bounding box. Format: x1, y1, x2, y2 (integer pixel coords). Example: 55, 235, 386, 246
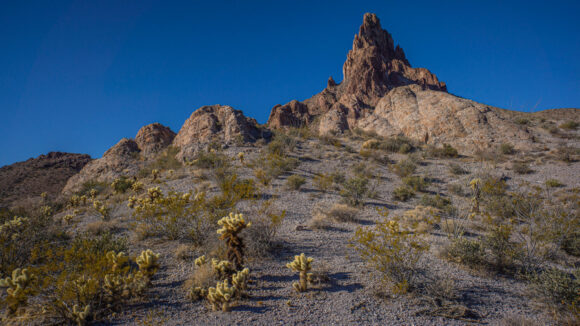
0, 152, 91, 207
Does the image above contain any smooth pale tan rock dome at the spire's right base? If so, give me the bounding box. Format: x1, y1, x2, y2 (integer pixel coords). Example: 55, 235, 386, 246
358, 85, 531, 153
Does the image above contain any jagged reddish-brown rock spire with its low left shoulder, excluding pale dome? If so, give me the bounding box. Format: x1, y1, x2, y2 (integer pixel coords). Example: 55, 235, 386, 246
268, 14, 447, 133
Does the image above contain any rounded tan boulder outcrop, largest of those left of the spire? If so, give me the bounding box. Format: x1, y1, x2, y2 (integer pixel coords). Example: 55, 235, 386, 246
173, 105, 268, 160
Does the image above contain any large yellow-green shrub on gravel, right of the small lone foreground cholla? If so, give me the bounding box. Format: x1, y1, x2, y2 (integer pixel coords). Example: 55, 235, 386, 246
350, 211, 429, 294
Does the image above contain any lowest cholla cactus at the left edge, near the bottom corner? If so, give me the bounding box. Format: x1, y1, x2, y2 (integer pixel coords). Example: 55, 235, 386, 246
0, 268, 37, 314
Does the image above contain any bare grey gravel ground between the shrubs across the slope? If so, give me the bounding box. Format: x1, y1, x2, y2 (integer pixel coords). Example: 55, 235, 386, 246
64, 132, 580, 325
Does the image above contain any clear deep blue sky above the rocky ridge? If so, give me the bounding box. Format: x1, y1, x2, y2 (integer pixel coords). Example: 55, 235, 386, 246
0, 0, 580, 166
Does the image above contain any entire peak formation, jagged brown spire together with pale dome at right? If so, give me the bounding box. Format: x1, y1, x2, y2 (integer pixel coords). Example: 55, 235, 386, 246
268, 14, 531, 153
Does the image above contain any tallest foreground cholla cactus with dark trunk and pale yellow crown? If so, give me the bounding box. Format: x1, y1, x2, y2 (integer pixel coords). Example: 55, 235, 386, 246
217, 213, 252, 270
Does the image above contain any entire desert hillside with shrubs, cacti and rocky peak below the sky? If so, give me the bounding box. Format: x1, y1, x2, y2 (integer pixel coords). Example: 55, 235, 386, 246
0, 14, 580, 325
